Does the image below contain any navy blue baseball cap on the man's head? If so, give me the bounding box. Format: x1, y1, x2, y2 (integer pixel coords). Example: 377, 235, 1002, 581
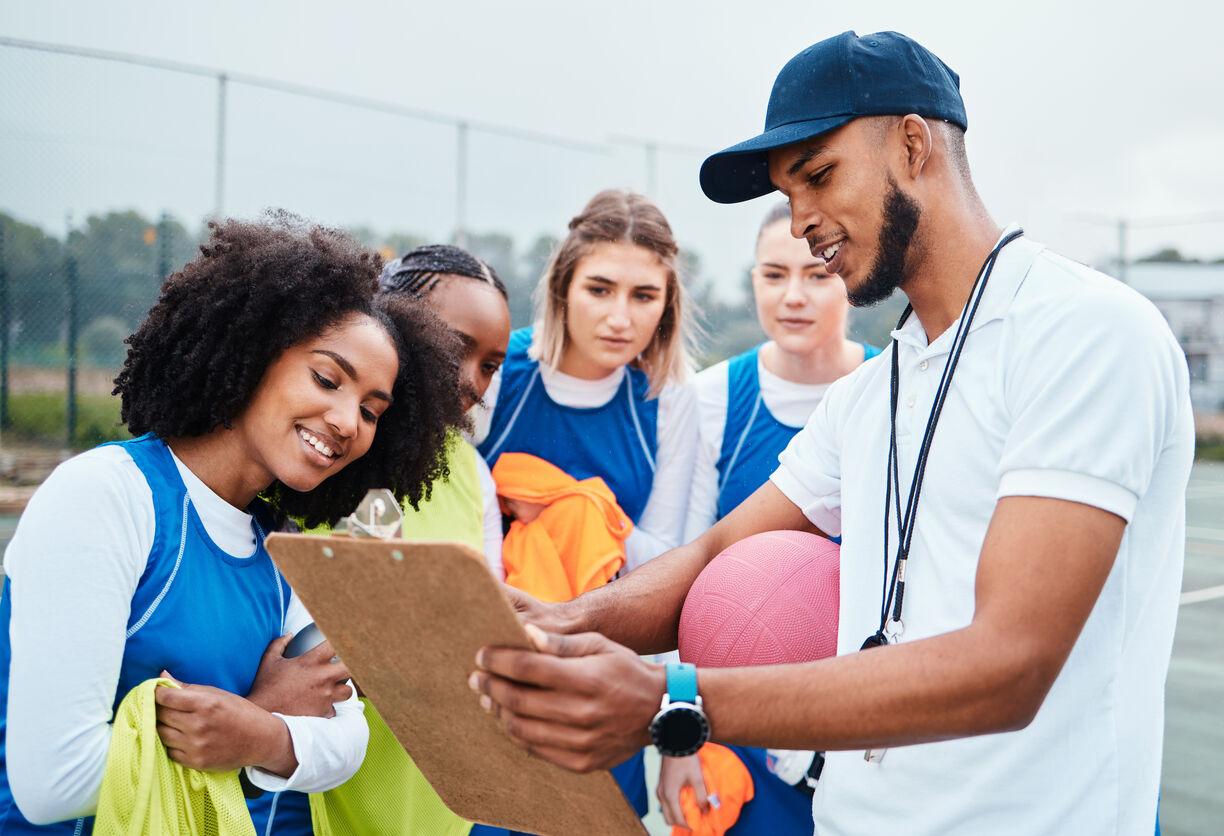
701, 32, 968, 203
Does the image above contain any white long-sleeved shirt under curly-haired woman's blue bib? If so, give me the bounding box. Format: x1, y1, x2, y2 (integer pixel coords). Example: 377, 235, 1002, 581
4, 447, 368, 823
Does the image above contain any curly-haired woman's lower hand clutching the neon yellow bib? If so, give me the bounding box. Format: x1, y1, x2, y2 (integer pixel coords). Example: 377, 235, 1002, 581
153, 671, 297, 776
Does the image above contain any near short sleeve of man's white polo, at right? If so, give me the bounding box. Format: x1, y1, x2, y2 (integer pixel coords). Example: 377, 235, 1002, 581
998, 263, 1189, 521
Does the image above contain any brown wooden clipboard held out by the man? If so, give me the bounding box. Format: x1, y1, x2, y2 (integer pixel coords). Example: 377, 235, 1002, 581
267, 534, 646, 836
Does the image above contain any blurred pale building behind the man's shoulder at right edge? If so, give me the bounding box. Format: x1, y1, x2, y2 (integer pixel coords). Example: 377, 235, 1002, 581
1126, 262, 1224, 410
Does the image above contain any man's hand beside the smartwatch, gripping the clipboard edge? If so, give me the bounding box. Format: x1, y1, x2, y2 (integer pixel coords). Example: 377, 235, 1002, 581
469, 624, 666, 772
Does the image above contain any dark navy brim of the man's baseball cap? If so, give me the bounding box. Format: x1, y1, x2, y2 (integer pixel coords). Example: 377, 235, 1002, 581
700, 114, 854, 203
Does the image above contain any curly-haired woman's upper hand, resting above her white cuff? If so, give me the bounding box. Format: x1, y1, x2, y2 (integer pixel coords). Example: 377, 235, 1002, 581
246, 634, 353, 717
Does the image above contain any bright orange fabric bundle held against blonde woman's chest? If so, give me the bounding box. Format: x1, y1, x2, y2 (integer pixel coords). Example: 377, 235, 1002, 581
493, 453, 633, 601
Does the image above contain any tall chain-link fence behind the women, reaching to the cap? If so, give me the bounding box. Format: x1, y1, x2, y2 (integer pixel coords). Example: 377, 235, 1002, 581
0, 37, 915, 448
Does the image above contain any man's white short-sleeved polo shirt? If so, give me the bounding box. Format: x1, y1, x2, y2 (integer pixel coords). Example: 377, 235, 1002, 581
771, 237, 1193, 836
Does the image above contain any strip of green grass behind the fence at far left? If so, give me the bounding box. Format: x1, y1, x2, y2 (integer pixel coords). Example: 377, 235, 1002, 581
4, 392, 131, 449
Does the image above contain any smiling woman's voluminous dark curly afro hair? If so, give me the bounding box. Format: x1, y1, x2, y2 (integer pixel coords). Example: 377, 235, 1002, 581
114, 212, 464, 526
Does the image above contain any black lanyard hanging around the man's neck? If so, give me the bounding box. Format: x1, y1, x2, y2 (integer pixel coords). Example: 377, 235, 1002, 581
862, 229, 1024, 650
